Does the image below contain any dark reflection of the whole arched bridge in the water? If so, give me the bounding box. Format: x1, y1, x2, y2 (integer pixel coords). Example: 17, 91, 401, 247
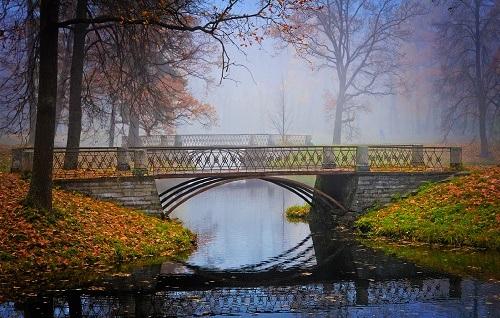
11, 212, 484, 317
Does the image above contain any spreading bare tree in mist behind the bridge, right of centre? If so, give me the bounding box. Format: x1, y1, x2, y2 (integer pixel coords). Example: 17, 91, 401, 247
281, 0, 423, 144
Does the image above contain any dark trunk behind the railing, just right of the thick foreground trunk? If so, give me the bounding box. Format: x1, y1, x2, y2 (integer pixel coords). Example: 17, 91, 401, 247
64, 0, 87, 170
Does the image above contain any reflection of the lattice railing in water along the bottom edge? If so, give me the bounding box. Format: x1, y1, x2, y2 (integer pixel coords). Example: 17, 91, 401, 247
14, 279, 464, 317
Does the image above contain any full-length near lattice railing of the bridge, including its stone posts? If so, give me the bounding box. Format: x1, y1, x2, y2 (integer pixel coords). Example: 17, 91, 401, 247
11, 145, 462, 179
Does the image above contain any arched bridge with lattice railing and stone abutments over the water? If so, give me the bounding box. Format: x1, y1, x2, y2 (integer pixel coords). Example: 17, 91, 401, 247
11, 145, 462, 214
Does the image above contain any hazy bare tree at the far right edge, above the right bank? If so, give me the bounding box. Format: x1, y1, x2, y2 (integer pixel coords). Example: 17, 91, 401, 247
436, 0, 500, 157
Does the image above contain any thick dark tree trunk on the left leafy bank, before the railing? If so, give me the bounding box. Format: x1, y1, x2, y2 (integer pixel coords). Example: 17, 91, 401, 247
27, 0, 59, 210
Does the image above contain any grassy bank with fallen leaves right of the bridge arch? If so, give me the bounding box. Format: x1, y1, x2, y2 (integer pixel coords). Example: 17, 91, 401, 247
356, 166, 500, 250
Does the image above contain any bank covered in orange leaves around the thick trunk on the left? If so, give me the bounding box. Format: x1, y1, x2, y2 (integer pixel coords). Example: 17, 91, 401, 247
0, 173, 195, 302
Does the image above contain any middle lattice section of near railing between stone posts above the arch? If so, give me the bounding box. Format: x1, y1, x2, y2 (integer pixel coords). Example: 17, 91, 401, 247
146, 147, 356, 174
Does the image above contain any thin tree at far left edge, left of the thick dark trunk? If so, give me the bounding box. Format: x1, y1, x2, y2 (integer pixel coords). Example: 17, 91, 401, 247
0, 0, 39, 145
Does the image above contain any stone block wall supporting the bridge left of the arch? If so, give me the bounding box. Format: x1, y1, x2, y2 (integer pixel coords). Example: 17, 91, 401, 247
55, 177, 161, 213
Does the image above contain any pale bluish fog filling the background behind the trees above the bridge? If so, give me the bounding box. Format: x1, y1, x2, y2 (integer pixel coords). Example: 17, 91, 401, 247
2, 1, 500, 155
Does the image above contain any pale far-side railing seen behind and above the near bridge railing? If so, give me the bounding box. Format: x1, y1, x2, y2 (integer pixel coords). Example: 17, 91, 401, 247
122, 134, 312, 147
